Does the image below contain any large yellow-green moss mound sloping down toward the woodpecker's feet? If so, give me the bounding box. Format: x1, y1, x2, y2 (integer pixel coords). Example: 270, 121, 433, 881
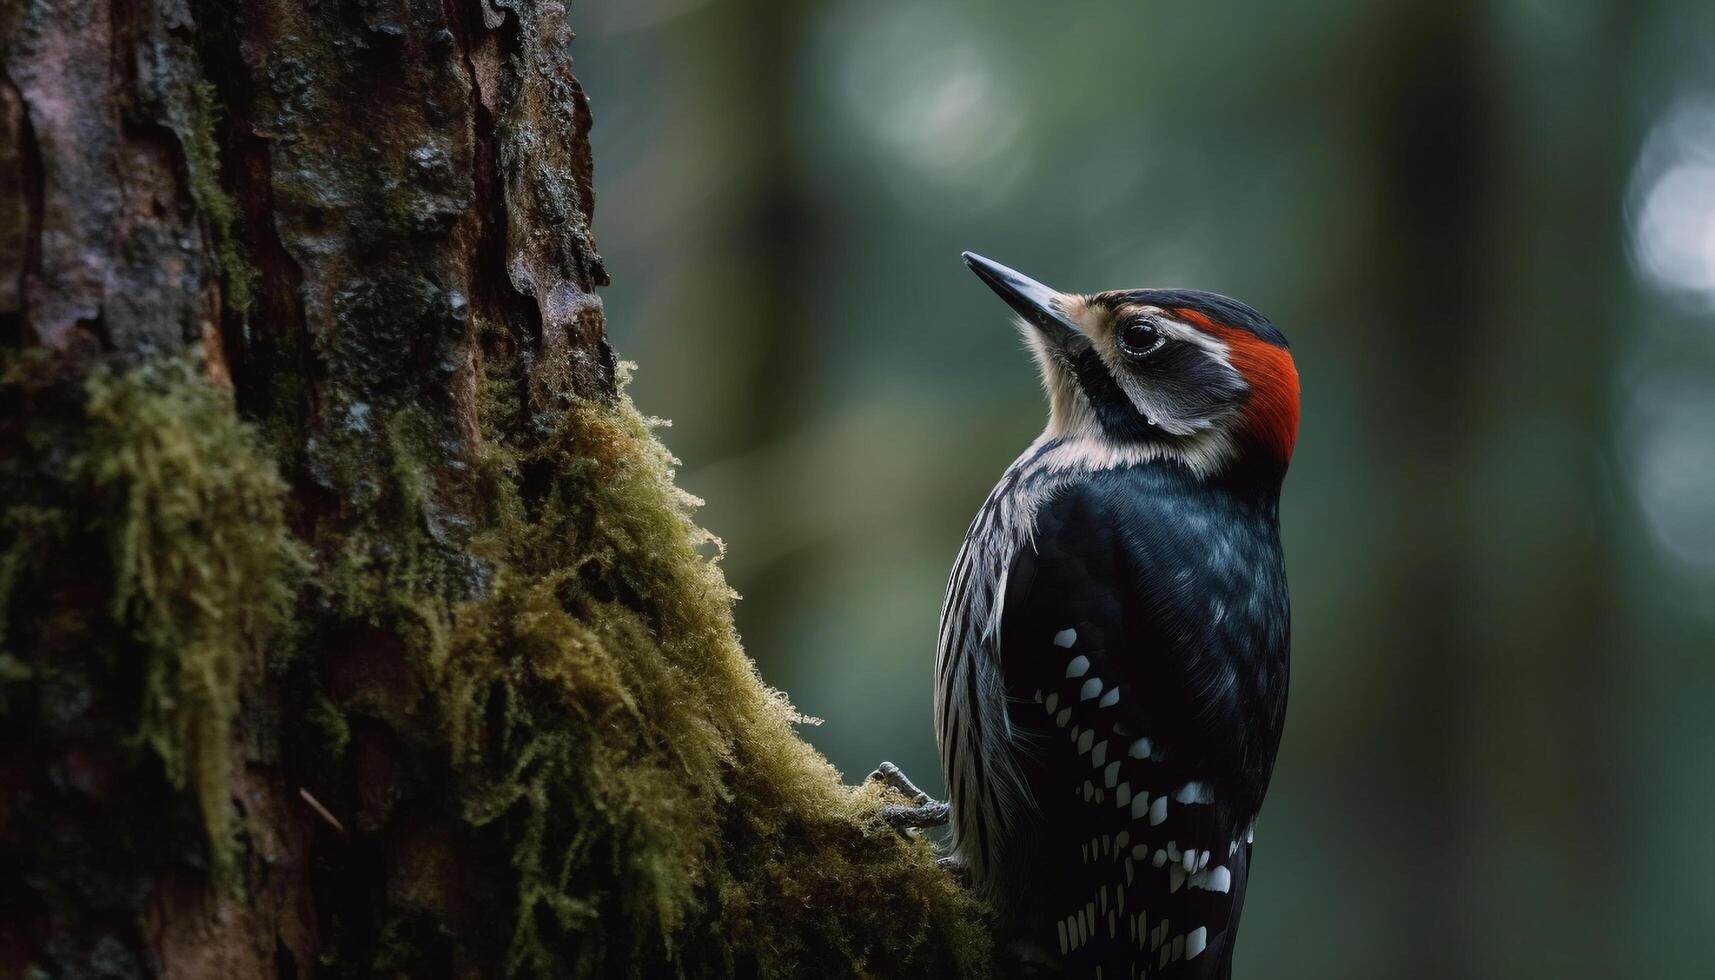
420, 370, 988, 977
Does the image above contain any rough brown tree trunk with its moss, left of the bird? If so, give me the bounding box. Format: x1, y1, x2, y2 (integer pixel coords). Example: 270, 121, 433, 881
0, 0, 988, 978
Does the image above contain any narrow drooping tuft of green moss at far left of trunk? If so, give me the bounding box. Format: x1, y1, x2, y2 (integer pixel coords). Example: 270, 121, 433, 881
70, 366, 297, 872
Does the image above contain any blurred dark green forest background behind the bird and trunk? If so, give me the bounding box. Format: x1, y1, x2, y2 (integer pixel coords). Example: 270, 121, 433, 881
575, 0, 1715, 978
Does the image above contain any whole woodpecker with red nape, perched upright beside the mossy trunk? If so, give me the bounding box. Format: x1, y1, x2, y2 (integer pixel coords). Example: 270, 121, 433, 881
878, 252, 1298, 980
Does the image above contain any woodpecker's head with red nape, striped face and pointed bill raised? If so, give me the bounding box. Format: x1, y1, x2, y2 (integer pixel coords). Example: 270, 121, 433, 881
964, 252, 1298, 477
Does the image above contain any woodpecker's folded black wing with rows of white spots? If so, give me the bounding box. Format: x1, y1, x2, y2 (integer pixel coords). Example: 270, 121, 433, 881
1000, 477, 1254, 977
